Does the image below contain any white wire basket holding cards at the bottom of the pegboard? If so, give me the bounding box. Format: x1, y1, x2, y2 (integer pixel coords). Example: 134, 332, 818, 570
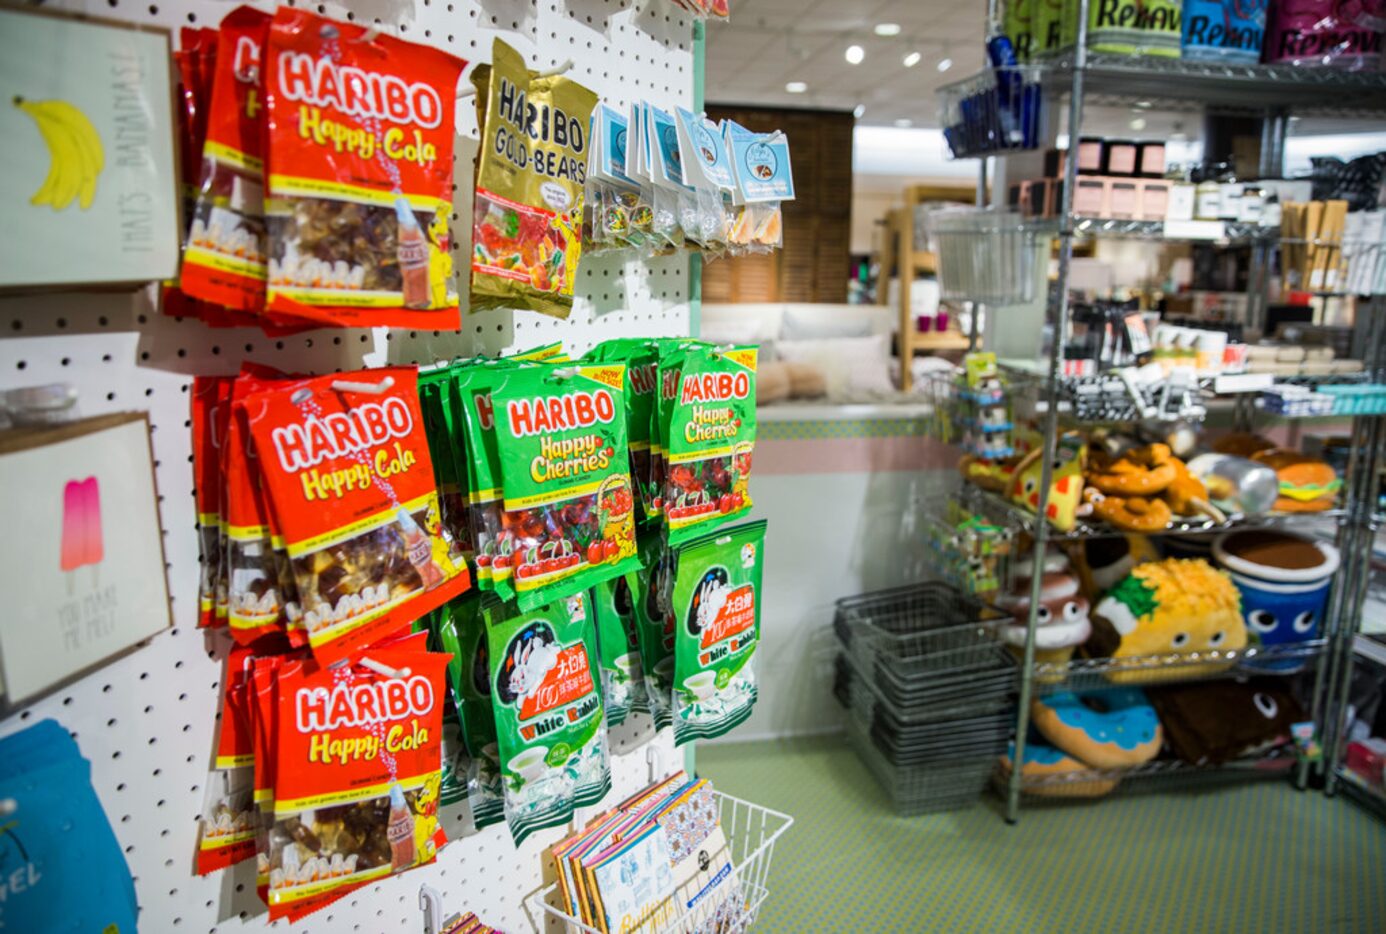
532, 790, 794, 934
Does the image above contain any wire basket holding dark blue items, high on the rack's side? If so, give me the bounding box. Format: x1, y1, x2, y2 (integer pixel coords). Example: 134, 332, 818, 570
938, 65, 1044, 159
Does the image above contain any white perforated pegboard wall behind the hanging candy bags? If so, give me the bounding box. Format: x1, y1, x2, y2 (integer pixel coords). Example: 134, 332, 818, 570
0, 0, 694, 934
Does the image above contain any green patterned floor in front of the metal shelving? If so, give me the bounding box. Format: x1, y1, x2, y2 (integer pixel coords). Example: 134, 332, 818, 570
697, 737, 1386, 934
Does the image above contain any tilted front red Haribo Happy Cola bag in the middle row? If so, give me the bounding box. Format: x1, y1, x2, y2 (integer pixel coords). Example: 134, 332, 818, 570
244, 367, 470, 664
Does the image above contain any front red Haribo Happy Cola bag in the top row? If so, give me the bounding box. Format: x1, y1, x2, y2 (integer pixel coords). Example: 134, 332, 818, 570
265, 7, 466, 330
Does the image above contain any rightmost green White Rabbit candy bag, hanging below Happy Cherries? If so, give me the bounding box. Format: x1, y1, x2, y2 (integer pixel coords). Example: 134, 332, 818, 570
671, 521, 765, 746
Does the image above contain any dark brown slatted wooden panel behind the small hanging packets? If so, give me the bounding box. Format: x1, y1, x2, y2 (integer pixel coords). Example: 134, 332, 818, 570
703, 104, 855, 303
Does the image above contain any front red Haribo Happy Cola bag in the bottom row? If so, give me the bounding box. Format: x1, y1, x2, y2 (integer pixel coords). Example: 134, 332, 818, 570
269, 646, 448, 920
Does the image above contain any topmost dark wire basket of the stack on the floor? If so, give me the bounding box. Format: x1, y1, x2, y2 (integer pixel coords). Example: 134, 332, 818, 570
833, 581, 1010, 676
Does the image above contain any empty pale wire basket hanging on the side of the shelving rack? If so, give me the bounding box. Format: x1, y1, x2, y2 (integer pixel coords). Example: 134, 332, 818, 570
916, 206, 1049, 305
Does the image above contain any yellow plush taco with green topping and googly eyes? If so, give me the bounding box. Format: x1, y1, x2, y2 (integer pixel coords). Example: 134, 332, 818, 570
1088, 558, 1246, 685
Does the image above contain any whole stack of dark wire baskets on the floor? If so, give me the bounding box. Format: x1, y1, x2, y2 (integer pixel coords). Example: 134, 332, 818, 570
833, 582, 1016, 813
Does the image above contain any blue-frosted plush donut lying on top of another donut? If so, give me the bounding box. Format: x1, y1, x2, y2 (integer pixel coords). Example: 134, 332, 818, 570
1030, 687, 1164, 769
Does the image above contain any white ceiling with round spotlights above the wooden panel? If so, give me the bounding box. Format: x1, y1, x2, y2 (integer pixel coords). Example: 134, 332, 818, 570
705, 0, 987, 126
